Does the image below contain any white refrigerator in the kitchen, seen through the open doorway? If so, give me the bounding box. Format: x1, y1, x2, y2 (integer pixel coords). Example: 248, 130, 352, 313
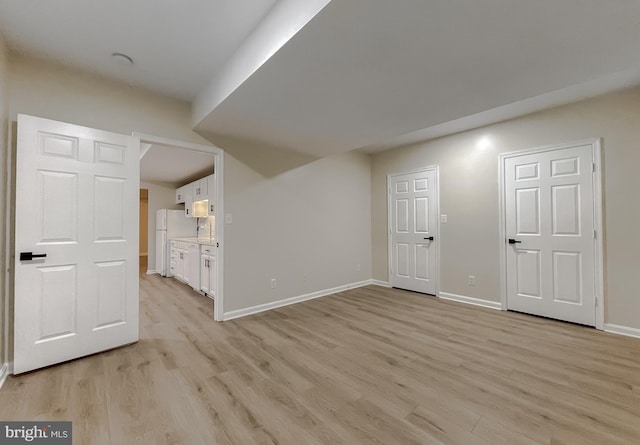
156, 209, 197, 277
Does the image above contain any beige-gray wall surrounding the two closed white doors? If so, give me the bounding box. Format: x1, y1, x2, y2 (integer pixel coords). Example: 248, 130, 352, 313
372, 88, 640, 328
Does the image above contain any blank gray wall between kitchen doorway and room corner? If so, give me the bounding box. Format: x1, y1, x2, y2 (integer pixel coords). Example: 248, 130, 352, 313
220, 146, 371, 312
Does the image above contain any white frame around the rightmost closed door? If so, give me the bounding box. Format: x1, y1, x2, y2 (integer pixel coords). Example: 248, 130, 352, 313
498, 138, 604, 330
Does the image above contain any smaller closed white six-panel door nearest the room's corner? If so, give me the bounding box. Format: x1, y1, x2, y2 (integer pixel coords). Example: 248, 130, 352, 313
389, 168, 438, 295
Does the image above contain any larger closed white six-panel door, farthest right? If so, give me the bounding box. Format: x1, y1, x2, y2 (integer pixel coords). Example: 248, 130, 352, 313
504, 145, 596, 326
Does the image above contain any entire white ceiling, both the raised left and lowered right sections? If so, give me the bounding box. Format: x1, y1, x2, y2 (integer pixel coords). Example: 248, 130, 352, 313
0, 0, 640, 162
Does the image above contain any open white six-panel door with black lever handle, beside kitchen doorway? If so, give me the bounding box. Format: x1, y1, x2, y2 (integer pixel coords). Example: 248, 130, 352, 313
14, 115, 139, 374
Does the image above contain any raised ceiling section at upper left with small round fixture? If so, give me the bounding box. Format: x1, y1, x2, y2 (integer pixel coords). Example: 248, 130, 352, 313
0, 0, 276, 101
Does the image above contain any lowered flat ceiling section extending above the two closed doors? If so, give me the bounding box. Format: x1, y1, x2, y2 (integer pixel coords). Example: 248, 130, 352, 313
198, 0, 640, 156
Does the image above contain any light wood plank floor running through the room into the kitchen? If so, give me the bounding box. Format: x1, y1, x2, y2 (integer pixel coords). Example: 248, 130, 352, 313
0, 275, 640, 445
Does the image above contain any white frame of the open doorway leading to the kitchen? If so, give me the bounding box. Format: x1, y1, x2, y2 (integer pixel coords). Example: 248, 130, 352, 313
133, 132, 224, 321
